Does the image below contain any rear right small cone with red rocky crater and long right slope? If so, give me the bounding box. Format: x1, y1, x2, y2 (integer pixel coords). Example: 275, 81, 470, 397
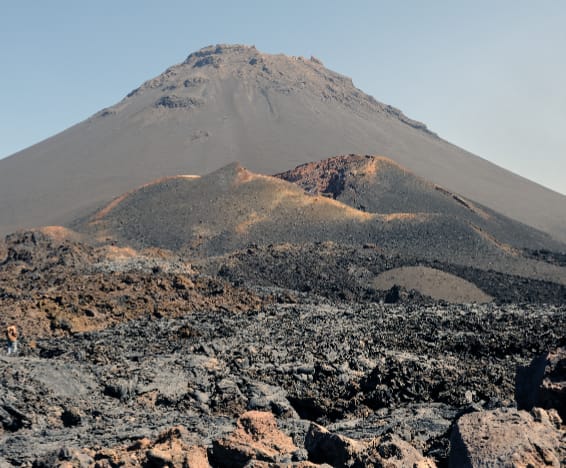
276, 154, 566, 251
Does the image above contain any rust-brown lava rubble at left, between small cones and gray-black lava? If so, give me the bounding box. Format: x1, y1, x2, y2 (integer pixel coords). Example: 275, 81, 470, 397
0, 230, 268, 338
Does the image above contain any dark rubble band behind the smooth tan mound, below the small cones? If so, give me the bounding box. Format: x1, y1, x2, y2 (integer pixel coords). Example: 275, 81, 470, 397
211, 242, 566, 305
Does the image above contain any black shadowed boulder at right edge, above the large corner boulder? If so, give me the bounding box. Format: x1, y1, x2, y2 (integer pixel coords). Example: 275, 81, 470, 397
515, 348, 566, 420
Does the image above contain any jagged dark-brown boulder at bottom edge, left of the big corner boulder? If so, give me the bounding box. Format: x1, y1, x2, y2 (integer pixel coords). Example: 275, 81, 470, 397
305, 423, 436, 468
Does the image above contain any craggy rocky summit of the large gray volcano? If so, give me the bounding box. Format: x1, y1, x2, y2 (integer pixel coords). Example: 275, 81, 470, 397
120, 44, 436, 137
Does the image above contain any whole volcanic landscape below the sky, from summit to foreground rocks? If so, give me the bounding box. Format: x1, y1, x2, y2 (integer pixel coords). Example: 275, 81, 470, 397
0, 46, 566, 468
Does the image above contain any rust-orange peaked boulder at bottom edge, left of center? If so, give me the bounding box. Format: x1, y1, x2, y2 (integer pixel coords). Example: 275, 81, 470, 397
212, 411, 297, 467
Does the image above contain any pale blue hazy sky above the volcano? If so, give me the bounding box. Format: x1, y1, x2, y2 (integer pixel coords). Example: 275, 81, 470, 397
0, 0, 566, 194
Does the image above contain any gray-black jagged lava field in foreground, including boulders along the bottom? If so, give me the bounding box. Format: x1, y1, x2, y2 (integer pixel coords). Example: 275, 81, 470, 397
0, 298, 566, 467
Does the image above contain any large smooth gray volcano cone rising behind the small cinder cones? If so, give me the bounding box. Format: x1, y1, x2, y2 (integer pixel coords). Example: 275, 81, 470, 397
0, 46, 566, 241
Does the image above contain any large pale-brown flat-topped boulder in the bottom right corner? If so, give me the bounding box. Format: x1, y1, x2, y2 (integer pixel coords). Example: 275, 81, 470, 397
449, 408, 566, 468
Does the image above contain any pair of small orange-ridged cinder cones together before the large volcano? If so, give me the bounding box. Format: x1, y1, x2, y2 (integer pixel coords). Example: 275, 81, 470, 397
77, 155, 566, 284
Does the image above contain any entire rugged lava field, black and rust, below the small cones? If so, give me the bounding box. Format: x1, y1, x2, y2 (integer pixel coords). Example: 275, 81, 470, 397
0, 229, 566, 467
